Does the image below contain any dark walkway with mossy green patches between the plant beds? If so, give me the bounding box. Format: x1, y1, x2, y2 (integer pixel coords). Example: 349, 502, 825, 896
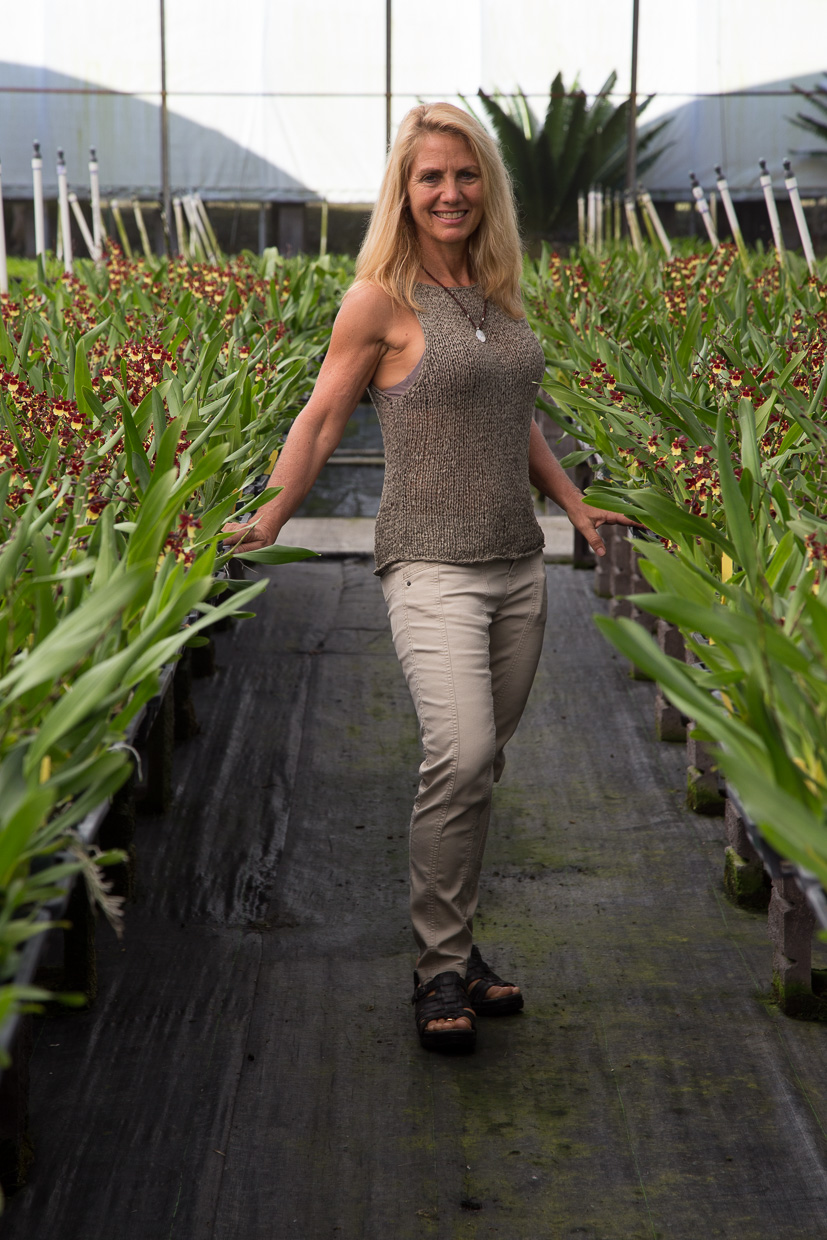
2, 560, 827, 1240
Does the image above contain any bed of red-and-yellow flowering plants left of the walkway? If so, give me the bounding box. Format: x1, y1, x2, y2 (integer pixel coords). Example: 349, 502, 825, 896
0, 249, 350, 1056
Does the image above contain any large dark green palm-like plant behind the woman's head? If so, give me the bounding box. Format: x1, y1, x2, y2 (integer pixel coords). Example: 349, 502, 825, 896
479, 73, 668, 239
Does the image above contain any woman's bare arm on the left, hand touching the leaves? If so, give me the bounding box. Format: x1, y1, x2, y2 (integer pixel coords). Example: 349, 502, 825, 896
224, 288, 392, 551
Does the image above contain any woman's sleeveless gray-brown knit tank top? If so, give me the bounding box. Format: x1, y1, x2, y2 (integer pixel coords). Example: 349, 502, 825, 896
369, 284, 546, 573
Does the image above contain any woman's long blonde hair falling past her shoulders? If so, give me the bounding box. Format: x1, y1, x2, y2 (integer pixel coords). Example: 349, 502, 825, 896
356, 103, 524, 319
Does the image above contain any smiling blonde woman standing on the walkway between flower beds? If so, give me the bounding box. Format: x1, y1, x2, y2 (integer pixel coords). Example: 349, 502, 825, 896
223, 103, 629, 1052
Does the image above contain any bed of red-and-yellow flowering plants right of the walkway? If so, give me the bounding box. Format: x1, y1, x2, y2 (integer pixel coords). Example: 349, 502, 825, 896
526, 241, 827, 885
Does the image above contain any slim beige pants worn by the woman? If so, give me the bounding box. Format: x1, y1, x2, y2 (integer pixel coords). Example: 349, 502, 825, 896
382, 552, 547, 981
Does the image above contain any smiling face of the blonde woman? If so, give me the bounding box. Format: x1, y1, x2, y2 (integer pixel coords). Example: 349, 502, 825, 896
408, 134, 482, 244
